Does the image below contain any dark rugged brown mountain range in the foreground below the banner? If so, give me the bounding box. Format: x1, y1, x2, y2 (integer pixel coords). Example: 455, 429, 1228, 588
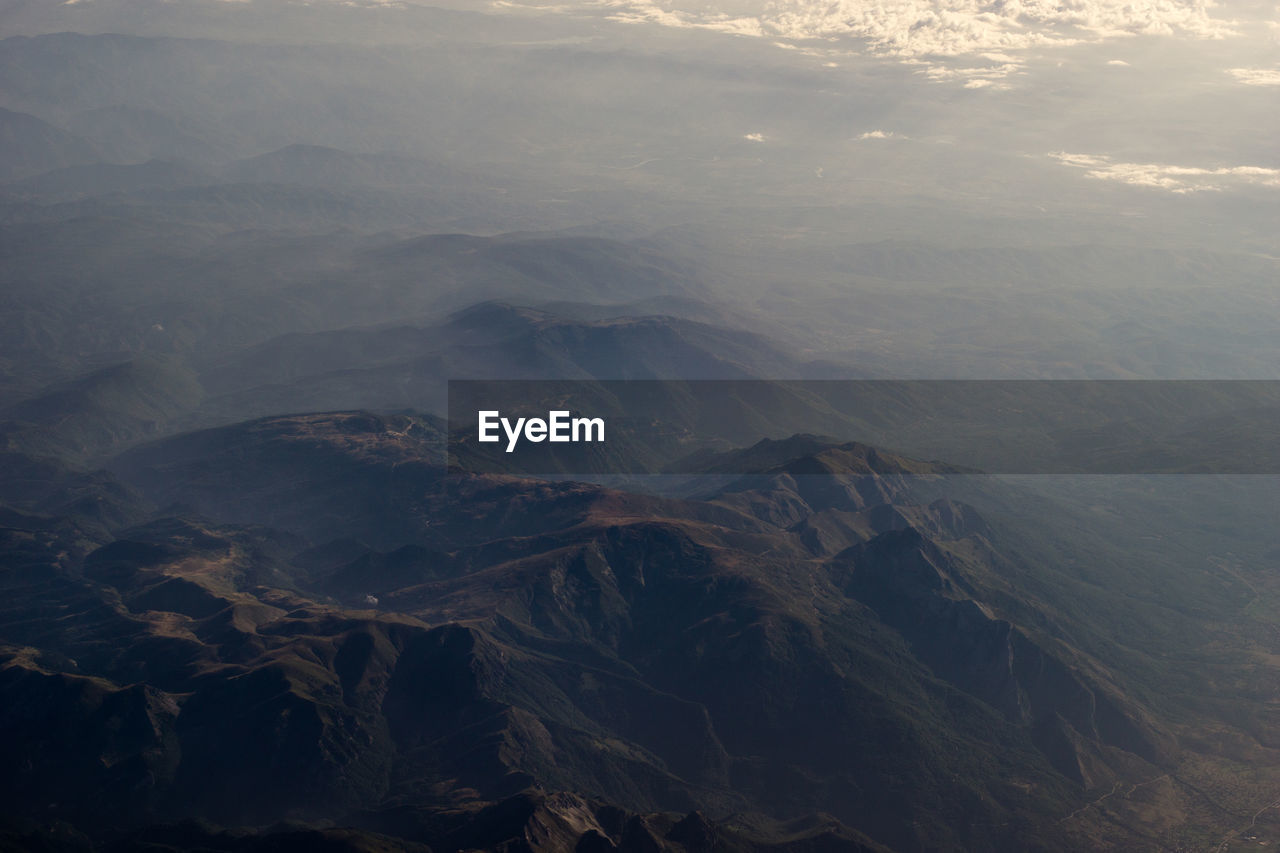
0, 412, 1274, 850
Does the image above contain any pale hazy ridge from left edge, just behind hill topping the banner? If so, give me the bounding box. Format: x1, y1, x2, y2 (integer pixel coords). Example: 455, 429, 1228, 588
0, 219, 721, 394
